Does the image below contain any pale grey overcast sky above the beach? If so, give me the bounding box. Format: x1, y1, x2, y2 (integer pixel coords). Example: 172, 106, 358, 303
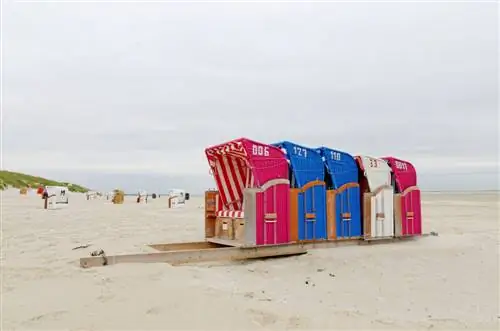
2, 0, 499, 190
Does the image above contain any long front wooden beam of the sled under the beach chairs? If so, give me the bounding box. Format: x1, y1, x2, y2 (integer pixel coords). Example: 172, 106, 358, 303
80, 245, 307, 268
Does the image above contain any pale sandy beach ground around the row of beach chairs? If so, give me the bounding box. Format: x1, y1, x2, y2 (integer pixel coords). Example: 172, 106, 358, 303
1, 190, 500, 330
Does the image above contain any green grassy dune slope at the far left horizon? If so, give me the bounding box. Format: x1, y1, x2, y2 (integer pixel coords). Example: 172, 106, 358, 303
0, 170, 89, 193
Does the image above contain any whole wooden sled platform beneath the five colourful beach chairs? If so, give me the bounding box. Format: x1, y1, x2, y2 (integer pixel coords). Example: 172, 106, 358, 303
80, 232, 437, 268
